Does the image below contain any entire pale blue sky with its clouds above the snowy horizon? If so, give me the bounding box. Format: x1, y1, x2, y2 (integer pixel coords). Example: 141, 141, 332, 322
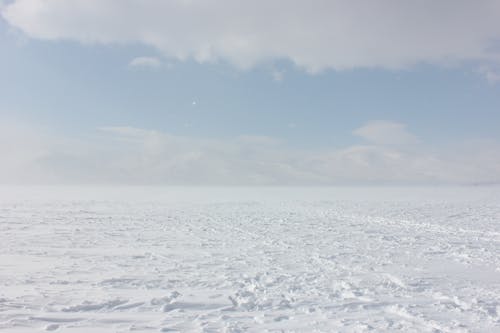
0, 0, 500, 185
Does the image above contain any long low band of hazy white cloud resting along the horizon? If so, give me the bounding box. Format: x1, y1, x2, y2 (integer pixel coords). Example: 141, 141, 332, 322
0, 121, 500, 185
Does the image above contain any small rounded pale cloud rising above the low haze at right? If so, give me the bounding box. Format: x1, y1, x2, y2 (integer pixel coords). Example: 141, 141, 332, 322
353, 120, 418, 145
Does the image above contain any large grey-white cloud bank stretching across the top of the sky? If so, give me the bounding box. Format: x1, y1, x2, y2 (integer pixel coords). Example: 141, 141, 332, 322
2, 0, 500, 72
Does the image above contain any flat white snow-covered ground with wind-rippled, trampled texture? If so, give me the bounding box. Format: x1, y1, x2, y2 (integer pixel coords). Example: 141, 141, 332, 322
0, 187, 500, 332
